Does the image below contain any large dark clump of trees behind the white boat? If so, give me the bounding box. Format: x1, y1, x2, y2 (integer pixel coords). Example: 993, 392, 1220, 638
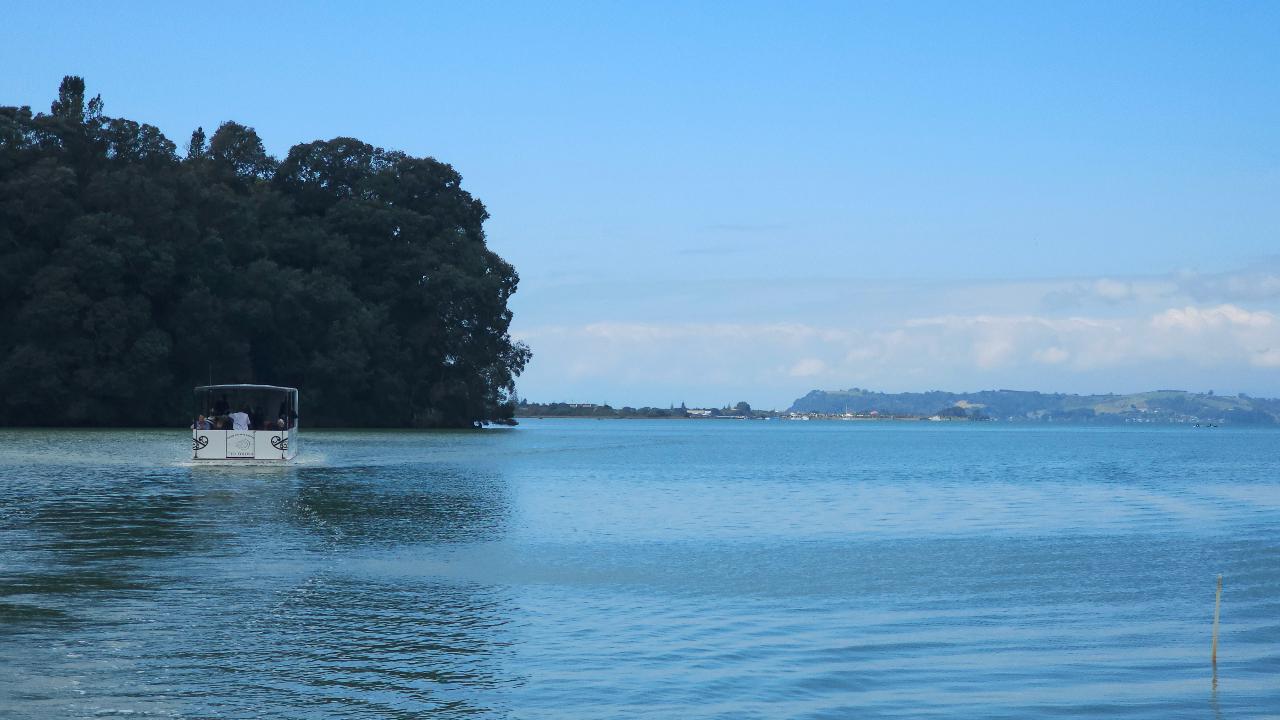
0, 77, 529, 427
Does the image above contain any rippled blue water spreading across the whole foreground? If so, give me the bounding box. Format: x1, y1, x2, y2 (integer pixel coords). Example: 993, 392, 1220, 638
0, 420, 1280, 719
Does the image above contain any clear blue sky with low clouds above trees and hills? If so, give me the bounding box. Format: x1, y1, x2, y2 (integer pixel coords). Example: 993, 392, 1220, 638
0, 1, 1280, 409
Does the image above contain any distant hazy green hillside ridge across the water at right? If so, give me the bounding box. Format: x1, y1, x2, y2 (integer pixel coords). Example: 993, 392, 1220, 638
787, 387, 1280, 425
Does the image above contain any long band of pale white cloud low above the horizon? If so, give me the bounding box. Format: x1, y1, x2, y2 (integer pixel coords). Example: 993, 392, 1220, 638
521, 304, 1280, 406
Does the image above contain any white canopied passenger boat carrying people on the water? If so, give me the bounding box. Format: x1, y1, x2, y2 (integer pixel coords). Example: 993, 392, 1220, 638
191, 384, 298, 464
